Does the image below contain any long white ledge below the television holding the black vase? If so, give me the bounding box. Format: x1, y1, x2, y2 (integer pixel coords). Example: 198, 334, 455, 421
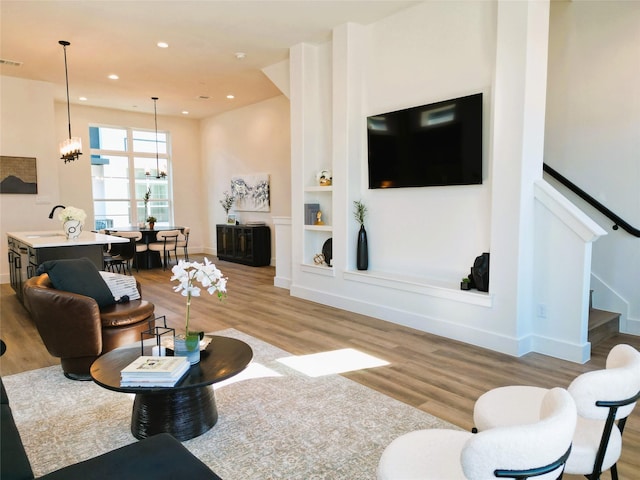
344, 270, 493, 307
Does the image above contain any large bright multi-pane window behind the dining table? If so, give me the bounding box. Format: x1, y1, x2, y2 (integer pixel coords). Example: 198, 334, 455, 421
89, 127, 173, 230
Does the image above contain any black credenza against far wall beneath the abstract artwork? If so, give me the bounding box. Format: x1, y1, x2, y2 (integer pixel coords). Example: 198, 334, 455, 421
216, 225, 271, 267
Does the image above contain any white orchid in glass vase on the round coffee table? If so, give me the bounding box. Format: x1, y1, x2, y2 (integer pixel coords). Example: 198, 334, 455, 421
171, 257, 227, 364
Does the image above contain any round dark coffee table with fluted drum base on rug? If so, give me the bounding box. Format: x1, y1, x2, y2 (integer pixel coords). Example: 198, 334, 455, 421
91, 335, 253, 441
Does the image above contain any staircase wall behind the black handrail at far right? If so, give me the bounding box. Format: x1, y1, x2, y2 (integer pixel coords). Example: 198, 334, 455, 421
544, 1, 640, 334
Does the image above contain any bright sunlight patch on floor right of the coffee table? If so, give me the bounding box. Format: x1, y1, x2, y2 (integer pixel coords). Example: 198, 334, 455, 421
278, 348, 389, 377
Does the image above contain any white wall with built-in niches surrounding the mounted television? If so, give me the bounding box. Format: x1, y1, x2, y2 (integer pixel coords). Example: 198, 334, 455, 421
290, 2, 604, 361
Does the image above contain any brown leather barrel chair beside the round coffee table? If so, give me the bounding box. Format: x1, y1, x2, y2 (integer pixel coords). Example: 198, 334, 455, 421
24, 273, 155, 380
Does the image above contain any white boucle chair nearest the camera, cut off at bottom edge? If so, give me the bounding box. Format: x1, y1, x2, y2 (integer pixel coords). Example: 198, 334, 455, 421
378, 388, 577, 480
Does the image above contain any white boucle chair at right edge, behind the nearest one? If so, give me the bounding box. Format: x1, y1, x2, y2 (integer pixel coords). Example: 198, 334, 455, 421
473, 344, 640, 480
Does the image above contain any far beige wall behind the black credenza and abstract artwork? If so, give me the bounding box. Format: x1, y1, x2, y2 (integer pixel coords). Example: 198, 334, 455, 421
201, 96, 291, 264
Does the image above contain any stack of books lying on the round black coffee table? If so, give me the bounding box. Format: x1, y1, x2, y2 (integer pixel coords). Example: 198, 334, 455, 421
120, 355, 191, 387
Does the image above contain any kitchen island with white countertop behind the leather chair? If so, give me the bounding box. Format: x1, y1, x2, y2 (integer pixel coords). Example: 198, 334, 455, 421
7, 230, 129, 302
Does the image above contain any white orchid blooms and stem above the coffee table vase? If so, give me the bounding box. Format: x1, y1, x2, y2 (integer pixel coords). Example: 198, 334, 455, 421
171, 257, 227, 341
